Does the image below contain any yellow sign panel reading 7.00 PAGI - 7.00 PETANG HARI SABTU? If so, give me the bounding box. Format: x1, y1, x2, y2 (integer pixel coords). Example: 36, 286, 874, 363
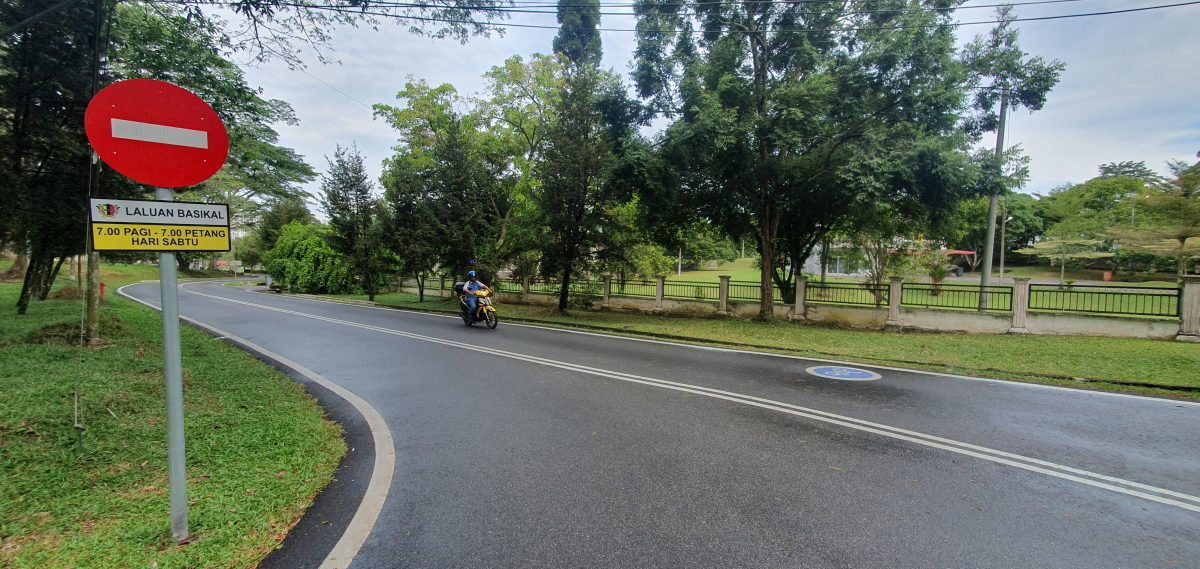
91, 223, 229, 251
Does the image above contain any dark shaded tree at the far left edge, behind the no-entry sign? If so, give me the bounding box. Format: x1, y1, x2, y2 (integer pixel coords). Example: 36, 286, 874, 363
0, 0, 121, 315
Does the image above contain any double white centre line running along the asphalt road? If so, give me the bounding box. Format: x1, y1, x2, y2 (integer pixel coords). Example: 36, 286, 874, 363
177, 286, 1200, 513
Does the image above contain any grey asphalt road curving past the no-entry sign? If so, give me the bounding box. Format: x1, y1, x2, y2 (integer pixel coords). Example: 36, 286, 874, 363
125, 282, 1200, 569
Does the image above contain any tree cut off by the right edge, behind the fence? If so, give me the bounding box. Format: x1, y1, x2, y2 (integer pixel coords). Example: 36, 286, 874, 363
1109, 161, 1200, 276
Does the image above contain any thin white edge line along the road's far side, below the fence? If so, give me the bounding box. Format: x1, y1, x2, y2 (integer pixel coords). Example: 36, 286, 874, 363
246, 291, 1200, 407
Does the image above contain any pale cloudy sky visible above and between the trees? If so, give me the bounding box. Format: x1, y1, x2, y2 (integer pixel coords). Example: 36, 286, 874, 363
234, 0, 1200, 203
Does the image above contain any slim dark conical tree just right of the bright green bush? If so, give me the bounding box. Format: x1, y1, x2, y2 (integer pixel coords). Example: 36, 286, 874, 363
320, 146, 392, 301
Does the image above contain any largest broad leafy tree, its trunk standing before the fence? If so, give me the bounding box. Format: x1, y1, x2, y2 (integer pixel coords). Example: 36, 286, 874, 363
634, 0, 964, 318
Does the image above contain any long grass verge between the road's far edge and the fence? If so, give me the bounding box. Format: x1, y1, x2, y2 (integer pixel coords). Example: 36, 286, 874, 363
340, 293, 1200, 400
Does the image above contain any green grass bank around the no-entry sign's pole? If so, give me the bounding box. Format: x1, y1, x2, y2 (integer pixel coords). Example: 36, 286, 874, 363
0, 265, 346, 568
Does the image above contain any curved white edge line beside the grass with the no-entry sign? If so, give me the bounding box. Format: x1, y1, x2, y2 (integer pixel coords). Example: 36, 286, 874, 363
116, 282, 396, 569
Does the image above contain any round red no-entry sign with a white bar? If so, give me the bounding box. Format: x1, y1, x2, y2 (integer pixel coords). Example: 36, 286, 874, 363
83, 79, 229, 187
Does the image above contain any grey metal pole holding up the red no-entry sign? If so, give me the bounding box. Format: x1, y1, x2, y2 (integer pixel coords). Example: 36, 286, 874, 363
155, 187, 190, 543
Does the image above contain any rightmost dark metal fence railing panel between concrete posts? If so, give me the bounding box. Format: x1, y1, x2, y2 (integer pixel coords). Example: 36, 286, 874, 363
1030, 285, 1180, 318
